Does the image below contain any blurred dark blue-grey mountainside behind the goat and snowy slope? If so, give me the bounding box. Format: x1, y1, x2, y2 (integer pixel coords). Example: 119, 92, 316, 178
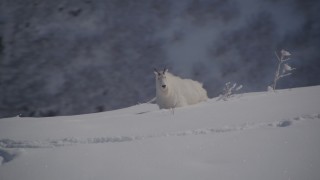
0, 0, 320, 117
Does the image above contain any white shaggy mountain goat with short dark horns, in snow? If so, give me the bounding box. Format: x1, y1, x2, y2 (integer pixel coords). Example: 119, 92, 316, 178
154, 68, 208, 109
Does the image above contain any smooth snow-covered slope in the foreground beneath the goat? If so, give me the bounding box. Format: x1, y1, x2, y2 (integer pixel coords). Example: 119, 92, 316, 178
0, 86, 320, 180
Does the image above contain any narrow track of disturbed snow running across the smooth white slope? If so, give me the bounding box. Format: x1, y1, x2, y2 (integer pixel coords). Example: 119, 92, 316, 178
0, 114, 320, 149
